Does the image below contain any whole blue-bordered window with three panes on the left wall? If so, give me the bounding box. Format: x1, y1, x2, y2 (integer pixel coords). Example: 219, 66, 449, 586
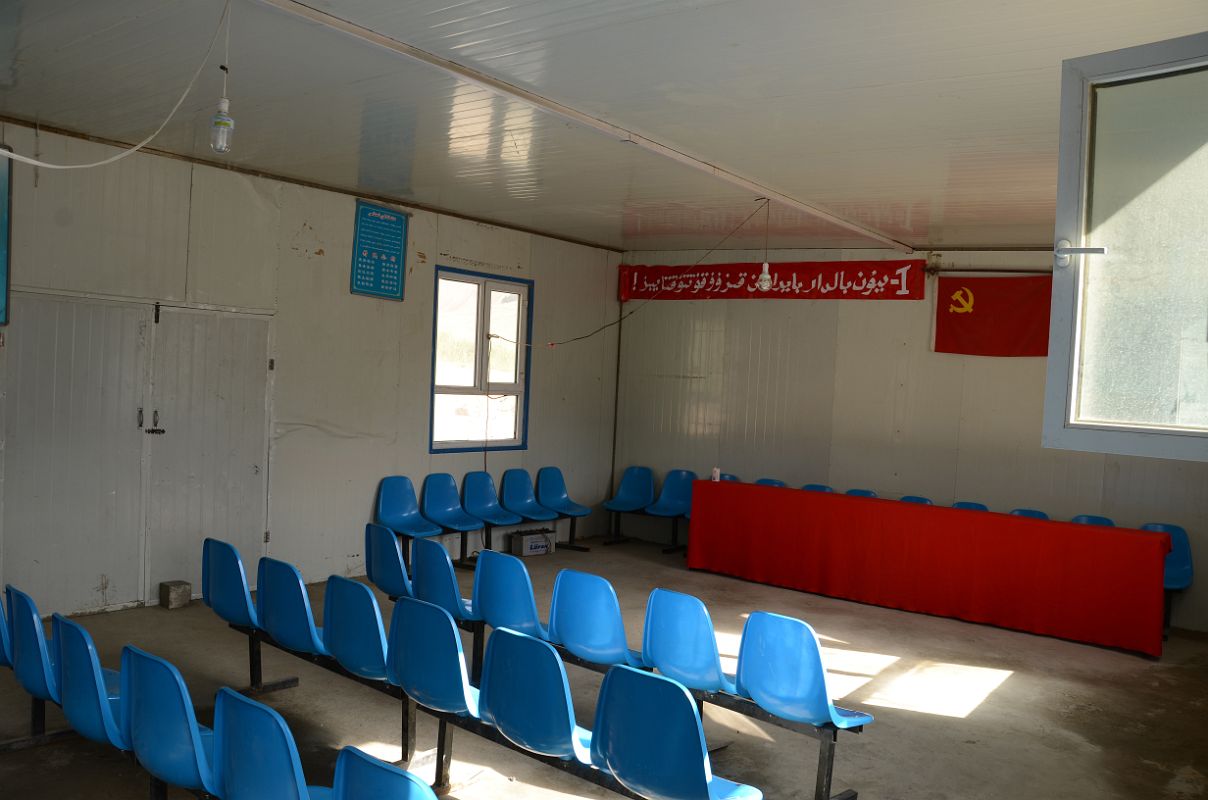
431, 267, 533, 453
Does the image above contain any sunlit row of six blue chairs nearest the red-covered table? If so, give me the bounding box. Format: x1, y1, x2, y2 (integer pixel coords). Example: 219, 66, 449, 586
355, 524, 872, 729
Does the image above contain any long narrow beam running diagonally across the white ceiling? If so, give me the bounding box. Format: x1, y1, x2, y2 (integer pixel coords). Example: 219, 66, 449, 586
257, 0, 914, 253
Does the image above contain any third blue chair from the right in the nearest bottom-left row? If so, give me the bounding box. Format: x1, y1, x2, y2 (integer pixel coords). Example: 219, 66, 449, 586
122, 644, 223, 798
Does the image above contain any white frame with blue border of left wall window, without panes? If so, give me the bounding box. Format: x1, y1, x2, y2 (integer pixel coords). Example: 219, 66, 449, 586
428, 266, 533, 453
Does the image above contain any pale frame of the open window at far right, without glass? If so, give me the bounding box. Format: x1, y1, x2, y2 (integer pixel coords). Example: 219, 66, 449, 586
1043, 34, 1208, 462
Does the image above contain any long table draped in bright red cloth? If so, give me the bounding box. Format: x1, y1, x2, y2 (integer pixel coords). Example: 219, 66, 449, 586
687, 481, 1171, 656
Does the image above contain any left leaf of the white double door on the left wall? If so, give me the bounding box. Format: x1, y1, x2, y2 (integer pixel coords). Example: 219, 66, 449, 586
2, 294, 150, 614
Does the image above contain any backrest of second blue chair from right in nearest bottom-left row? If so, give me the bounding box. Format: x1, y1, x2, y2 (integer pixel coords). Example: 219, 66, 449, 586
214, 686, 310, 800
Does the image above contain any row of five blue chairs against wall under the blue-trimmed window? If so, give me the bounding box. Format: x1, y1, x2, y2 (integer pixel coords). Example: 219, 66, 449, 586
377, 466, 591, 561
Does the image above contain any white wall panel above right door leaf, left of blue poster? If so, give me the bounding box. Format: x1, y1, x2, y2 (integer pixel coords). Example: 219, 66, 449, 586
186, 166, 283, 309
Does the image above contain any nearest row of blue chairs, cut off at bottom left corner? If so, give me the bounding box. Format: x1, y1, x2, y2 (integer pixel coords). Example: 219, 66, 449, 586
0, 586, 436, 800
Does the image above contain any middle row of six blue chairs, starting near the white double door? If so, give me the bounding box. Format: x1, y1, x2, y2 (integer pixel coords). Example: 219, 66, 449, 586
204, 539, 762, 800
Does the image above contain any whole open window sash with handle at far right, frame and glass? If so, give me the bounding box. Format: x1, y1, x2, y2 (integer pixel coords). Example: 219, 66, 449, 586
1045, 34, 1208, 460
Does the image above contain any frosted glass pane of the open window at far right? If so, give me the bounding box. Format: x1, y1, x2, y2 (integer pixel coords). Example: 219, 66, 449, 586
1074, 70, 1208, 430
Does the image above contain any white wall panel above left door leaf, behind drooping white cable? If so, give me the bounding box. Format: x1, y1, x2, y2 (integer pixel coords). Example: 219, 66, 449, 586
5, 124, 192, 301
